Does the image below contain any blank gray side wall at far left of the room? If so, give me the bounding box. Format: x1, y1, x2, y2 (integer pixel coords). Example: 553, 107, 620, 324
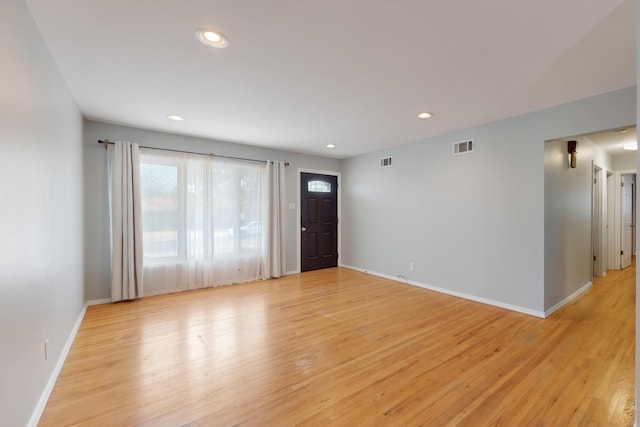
0, 0, 84, 426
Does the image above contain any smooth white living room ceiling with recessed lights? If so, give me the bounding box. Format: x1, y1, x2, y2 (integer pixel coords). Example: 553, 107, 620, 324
26, 0, 636, 158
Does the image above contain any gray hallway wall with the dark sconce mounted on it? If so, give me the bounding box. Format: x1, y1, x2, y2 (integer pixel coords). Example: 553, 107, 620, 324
544, 140, 613, 310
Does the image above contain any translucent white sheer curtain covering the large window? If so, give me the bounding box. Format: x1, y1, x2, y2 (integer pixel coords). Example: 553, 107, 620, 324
140, 149, 270, 295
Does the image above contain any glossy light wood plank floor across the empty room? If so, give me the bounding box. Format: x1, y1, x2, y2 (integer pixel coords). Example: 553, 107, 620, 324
40, 268, 635, 427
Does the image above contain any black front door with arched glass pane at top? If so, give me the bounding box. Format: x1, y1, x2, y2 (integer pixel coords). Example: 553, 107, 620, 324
300, 172, 338, 271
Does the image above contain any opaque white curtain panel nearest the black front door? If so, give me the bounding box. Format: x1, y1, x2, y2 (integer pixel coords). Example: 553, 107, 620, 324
265, 161, 286, 278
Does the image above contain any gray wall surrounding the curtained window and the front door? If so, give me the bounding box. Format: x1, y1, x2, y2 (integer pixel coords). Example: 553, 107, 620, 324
83, 121, 340, 301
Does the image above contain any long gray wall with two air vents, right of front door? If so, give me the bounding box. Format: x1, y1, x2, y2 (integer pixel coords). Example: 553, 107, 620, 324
342, 88, 636, 313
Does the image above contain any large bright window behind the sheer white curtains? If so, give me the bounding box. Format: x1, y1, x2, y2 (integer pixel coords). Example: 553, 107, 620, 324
140, 153, 265, 261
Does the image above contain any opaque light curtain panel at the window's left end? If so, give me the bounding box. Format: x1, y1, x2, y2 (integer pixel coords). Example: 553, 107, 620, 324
108, 141, 143, 302
